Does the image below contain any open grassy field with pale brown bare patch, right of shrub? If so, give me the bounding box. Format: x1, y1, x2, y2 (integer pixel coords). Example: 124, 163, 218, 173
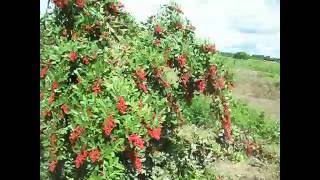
220, 57, 280, 120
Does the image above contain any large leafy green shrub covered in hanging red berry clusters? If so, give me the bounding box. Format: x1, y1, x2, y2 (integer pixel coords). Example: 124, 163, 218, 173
40, 0, 232, 179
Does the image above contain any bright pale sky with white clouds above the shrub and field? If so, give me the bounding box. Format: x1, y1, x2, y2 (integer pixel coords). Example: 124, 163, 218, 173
40, 0, 280, 58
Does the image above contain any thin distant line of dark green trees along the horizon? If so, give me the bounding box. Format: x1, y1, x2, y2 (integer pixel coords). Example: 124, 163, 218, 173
220, 52, 280, 62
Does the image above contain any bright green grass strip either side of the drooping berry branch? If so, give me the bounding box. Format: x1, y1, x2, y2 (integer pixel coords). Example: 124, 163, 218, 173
185, 93, 280, 144
